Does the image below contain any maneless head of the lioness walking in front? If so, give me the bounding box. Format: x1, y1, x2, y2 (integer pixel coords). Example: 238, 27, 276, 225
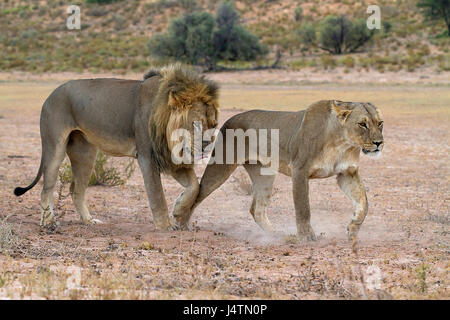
331, 100, 384, 157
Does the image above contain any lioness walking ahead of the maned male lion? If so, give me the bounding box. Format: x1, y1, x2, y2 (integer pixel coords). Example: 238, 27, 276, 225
189, 100, 384, 240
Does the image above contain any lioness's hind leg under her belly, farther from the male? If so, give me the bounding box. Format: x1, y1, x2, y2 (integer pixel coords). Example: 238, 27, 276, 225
244, 164, 275, 232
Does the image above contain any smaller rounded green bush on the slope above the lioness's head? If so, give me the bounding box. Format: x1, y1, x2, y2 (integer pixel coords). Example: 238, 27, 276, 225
319, 16, 373, 54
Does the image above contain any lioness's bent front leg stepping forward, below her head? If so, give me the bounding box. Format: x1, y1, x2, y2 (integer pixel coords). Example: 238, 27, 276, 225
337, 171, 368, 240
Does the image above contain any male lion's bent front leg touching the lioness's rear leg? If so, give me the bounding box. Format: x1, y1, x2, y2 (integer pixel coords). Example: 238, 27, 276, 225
172, 168, 200, 230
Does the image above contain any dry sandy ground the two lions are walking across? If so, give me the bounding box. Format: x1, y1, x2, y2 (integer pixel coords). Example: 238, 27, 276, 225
0, 82, 450, 299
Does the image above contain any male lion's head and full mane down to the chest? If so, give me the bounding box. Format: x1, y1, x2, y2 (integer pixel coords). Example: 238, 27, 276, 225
144, 64, 219, 171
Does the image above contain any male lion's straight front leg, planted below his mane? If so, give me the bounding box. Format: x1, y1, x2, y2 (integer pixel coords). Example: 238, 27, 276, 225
138, 155, 172, 230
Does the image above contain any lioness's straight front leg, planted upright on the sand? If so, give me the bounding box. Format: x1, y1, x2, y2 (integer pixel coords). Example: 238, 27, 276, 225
292, 170, 316, 240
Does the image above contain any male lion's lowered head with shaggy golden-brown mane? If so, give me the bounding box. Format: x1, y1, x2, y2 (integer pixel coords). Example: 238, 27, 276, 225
149, 64, 219, 166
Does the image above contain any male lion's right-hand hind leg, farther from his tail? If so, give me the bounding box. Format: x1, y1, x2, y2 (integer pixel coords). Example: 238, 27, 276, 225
67, 131, 101, 224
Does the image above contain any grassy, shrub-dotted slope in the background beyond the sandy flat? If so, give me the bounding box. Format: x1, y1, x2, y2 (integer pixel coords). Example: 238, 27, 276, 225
0, 0, 450, 74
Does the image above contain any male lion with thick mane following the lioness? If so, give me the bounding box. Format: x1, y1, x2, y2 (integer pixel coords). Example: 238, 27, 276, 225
14, 64, 218, 229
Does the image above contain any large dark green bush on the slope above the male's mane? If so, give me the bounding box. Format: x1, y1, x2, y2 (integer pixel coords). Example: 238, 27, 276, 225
147, 2, 267, 70
